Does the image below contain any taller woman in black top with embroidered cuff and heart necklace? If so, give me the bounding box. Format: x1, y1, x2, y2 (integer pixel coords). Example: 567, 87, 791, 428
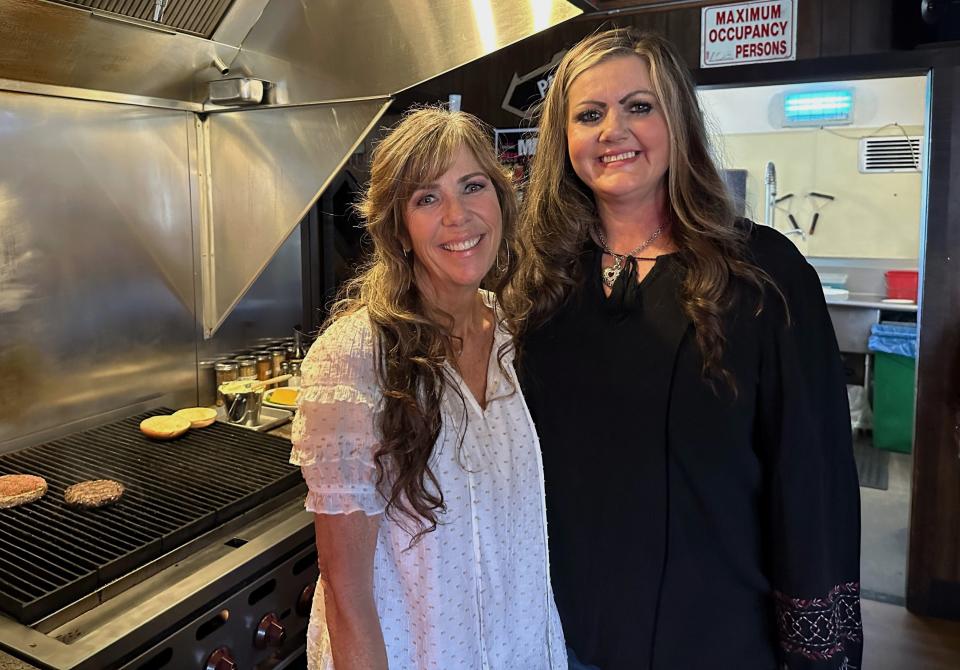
513, 30, 862, 670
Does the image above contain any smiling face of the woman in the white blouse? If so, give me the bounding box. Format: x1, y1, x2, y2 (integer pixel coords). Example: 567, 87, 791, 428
404, 147, 503, 298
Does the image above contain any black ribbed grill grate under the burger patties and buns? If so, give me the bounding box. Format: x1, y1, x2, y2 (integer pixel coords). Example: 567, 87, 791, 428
0, 409, 300, 624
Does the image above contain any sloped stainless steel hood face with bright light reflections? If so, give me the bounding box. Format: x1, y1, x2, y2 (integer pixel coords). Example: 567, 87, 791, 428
234, 0, 581, 103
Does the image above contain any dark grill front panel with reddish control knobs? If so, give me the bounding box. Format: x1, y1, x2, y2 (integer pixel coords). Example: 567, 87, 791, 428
122, 543, 318, 670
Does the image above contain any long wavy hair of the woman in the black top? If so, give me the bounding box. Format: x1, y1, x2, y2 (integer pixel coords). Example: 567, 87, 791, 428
508, 28, 770, 391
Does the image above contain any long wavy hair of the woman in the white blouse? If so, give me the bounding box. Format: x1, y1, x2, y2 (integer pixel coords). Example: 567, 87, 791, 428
327, 107, 518, 543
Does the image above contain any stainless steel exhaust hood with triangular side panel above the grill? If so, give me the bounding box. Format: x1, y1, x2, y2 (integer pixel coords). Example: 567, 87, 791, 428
0, 0, 581, 336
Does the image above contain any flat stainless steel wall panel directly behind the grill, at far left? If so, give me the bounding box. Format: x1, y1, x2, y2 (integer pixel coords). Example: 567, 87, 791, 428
0, 93, 196, 450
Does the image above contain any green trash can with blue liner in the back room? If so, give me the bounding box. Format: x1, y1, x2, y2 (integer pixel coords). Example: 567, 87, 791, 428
868, 323, 917, 454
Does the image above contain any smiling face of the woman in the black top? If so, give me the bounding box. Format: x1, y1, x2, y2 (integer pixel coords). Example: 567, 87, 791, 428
567, 55, 670, 209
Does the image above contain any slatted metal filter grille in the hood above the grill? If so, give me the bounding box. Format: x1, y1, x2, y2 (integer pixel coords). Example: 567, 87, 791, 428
54, 0, 233, 39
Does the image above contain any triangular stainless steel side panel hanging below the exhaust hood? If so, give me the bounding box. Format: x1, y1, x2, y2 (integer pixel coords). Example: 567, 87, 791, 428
203, 99, 390, 336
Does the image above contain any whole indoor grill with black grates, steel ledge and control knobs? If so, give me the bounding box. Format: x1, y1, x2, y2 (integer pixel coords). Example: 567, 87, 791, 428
0, 409, 317, 670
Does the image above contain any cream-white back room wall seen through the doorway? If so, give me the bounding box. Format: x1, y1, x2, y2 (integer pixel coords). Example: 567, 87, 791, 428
700, 77, 926, 259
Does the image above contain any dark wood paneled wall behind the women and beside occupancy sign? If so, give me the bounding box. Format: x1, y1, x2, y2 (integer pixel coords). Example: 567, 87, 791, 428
393, 0, 896, 128
